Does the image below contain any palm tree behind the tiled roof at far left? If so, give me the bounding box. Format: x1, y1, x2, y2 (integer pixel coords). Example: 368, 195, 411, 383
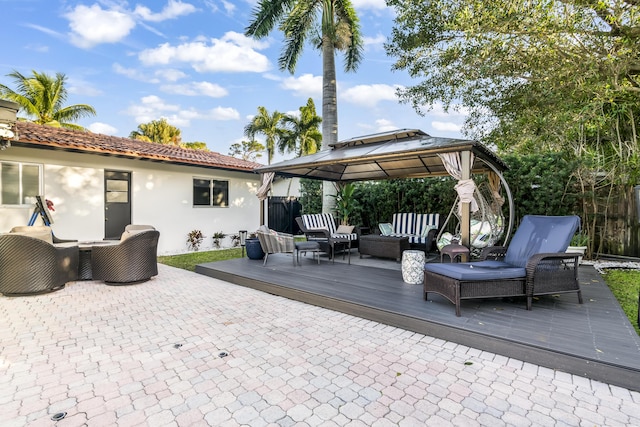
0, 70, 96, 130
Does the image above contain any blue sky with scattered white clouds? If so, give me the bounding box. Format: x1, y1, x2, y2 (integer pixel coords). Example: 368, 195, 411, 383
0, 0, 464, 163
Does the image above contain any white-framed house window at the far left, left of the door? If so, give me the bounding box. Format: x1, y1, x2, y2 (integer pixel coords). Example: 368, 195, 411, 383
0, 162, 42, 206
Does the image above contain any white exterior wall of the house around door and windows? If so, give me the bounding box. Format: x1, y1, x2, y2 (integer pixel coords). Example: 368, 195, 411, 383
0, 147, 260, 255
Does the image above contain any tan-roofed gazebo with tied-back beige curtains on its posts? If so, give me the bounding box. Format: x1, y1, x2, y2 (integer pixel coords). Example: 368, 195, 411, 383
255, 129, 514, 246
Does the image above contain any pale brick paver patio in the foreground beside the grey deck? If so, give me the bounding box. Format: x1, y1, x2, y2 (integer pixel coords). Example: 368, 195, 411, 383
0, 265, 640, 426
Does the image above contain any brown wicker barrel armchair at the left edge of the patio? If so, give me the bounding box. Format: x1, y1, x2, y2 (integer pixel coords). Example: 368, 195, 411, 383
0, 233, 78, 296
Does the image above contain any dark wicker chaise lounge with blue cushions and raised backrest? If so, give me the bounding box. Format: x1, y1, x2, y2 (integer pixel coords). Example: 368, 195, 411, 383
424, 215, 582, 316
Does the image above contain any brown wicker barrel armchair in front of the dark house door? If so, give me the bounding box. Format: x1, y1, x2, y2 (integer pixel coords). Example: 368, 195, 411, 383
91, 230, 160, 285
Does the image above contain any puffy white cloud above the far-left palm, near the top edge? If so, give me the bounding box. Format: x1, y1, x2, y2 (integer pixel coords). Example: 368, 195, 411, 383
65, 4, 136, 48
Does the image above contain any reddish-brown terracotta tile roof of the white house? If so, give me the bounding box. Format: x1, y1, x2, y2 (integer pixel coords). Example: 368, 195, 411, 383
12, 122, 263, 171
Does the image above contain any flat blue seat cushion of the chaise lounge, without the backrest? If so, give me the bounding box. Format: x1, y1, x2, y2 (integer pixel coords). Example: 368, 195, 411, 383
424, 261, 527, 281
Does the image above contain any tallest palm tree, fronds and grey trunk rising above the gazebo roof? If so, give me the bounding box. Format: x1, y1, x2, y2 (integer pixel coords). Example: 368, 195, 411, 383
245, 0, 363, 148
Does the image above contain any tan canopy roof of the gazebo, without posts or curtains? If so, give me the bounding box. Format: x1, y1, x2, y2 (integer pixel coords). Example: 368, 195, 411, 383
255, 129, 507, 182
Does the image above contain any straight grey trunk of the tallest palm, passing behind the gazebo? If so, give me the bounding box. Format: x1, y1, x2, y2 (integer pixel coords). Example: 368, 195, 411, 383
322, 36, 338, 213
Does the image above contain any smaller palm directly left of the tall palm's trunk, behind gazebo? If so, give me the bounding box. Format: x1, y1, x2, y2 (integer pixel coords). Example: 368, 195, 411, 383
278, 98, 322, 157
